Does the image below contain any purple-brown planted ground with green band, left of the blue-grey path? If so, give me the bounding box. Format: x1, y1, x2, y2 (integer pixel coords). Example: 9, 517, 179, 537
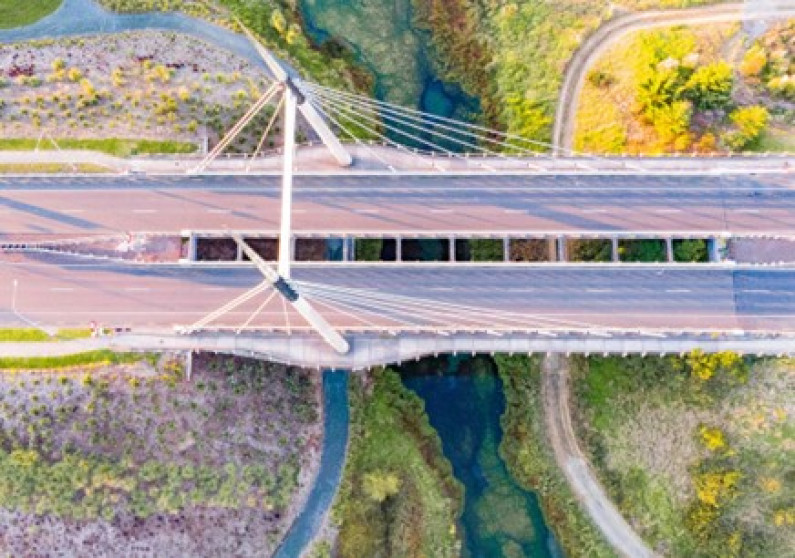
0, 352, 320, 556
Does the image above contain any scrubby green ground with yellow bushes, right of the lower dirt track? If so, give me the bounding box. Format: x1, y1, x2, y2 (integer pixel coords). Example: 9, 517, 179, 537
573, 351, 795, 558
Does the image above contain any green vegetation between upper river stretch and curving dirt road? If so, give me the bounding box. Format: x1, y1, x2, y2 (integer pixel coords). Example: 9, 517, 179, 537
414, 0, 724, 147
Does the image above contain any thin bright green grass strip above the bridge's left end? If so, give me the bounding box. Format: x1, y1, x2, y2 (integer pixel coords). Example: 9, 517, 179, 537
0, 138, 198, 157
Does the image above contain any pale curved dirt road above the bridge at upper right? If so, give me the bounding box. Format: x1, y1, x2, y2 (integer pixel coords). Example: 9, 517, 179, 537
552, 0, 795, 154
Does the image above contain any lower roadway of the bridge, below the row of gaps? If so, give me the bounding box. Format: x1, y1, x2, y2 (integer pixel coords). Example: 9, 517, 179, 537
0, 255, 795, 331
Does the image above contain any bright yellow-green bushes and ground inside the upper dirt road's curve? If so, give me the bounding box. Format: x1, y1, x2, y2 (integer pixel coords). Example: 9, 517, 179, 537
575, 21, 795, 154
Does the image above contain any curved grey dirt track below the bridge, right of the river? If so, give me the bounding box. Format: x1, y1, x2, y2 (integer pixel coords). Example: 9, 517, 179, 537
542, 355, 654, 558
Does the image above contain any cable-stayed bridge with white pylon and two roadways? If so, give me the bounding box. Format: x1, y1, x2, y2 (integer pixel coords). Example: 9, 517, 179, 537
0, 27, 795, 367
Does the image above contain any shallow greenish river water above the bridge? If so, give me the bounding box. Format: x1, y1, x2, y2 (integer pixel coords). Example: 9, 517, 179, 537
300, 0, 479, 118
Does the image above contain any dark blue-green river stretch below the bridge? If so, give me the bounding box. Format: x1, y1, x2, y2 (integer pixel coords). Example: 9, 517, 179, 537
401, 357, 562, 558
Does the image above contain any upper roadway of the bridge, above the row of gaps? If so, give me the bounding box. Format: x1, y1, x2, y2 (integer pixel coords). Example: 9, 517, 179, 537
0, 174, 795, 240
